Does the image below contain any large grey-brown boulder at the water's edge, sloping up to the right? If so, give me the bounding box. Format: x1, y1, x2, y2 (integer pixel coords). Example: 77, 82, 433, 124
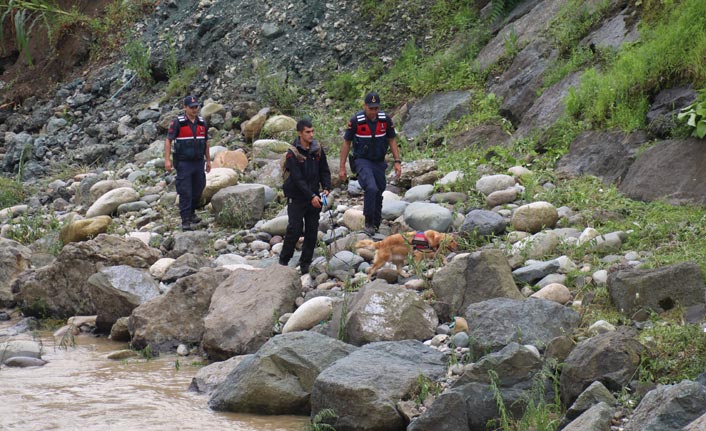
208, 331, 356, 415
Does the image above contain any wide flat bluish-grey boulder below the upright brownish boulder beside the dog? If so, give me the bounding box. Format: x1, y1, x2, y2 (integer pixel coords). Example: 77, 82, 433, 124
464, 298, 580, 351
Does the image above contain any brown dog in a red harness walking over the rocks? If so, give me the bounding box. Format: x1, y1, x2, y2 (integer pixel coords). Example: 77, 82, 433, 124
355, 230, 458, 277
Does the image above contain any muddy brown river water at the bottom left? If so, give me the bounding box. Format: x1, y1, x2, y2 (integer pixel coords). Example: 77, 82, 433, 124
0, 334, 307, 431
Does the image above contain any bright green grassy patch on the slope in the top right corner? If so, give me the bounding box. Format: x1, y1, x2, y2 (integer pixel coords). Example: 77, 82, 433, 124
567, 0, 706, 131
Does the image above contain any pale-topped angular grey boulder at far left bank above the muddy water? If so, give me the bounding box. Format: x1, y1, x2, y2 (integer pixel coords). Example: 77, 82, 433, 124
88, 265, 159, 332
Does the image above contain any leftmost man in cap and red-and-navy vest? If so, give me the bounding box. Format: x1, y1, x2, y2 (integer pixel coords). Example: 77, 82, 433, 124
164, 96, 211, 231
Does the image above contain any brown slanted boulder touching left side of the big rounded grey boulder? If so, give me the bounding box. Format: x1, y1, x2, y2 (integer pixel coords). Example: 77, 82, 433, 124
129, 268, 230, 352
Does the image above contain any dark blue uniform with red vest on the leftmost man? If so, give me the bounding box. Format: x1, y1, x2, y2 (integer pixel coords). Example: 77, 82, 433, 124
167, 114, 208, 225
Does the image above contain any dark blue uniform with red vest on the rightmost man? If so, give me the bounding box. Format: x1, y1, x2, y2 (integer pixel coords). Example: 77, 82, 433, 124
343, 111, 397, 230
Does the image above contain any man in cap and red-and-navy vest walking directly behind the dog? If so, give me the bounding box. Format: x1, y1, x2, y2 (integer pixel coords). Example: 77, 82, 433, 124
338, 92, 402, 236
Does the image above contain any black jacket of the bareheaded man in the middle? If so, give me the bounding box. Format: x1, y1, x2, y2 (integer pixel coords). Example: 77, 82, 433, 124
282, 138, 331, 201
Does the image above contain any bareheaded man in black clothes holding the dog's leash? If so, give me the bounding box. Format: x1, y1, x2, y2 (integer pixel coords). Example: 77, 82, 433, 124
279, 119, 331, 274
